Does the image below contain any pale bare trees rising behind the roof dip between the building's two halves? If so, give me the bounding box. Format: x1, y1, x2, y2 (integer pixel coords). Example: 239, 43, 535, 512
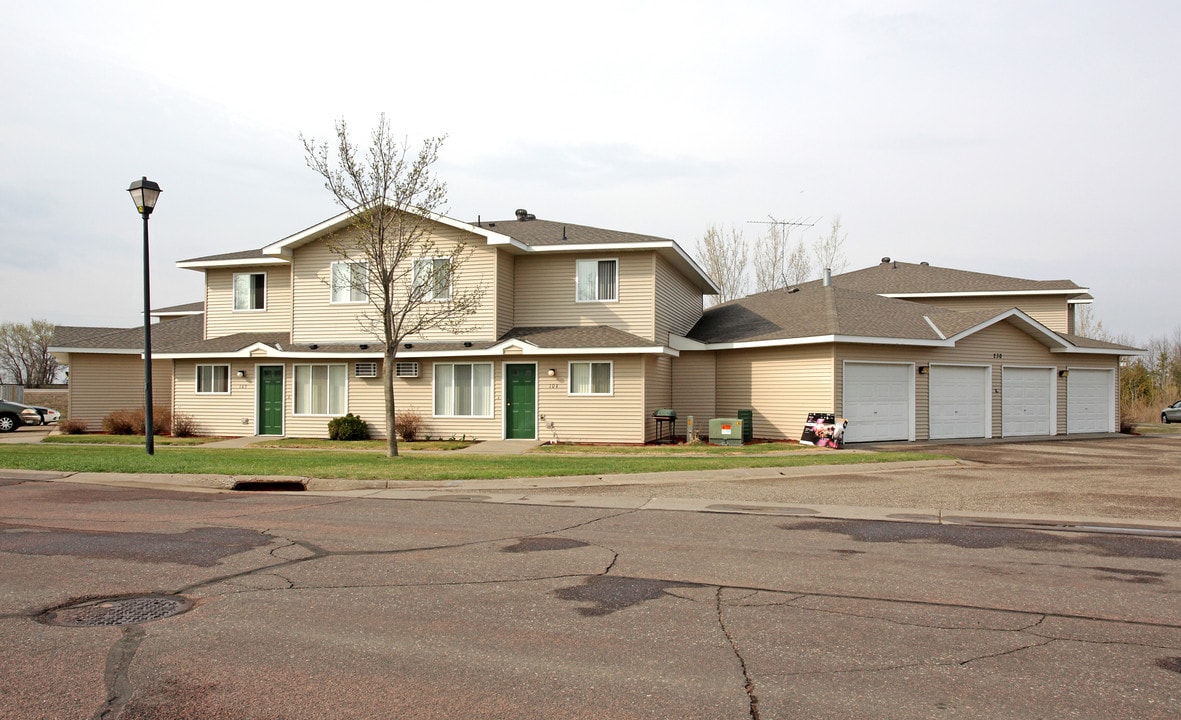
697, 215, 848, 305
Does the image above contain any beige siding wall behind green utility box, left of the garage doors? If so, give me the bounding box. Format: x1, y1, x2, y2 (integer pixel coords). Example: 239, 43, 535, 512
708, 345, 834, 440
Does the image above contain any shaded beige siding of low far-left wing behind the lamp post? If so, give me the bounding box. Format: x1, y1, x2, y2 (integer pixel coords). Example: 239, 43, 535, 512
68, 353, 172, 424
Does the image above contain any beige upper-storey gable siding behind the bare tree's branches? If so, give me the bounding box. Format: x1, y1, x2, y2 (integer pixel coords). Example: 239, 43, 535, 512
292, 225, 498, 343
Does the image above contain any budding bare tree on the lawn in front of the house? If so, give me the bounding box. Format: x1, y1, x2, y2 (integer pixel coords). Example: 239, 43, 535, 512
300, 113, 484, 458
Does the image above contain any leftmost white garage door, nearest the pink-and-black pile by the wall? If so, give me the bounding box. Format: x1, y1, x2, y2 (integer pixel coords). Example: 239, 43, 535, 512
843, 362, 914, 443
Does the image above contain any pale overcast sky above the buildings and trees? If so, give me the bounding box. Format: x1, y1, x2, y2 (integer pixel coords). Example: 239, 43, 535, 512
0, 0, 1181, 342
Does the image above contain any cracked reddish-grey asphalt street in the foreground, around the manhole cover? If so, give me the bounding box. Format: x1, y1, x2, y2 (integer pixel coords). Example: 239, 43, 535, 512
0, 474, 1181, 720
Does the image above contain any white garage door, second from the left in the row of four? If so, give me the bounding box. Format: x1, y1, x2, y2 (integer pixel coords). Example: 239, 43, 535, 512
928, 365, 992, 440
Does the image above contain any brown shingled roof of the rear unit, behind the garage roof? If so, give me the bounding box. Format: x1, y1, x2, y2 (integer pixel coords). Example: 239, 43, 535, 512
800, 260, 1090, 301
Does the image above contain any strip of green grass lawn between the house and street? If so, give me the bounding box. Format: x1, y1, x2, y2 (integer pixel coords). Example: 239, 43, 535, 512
0, 444, 946, 480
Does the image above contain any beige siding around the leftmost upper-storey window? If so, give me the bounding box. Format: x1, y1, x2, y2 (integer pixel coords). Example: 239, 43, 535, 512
205, 266, 292, 340
